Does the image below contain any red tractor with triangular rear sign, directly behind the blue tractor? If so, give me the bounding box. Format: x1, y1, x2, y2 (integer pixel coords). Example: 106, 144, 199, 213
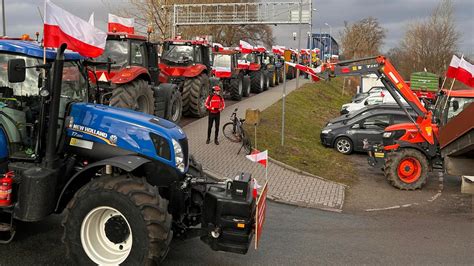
89, 32, 182, 123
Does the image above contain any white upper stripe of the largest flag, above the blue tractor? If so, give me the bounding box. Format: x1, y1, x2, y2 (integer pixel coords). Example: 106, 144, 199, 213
44, 0, 107, 49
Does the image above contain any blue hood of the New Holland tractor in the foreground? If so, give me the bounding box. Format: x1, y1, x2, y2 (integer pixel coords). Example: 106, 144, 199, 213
66, 103, 187, 168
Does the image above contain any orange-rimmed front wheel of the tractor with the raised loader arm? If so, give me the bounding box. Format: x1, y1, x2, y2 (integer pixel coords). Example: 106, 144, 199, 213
384, 149, 429, 190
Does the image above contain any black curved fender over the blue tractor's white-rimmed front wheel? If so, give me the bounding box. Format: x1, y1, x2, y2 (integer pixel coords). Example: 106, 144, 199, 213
55, 155, 151, 212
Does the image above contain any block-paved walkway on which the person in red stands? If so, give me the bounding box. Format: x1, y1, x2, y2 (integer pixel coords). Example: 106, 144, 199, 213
183, 79, 345, 211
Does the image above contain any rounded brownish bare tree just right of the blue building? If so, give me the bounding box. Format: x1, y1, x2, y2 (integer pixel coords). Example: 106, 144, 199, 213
341, 17, 385, 59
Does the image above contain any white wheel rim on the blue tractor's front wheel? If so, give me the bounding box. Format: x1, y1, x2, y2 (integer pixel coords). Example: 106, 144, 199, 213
80, 206, 133, 265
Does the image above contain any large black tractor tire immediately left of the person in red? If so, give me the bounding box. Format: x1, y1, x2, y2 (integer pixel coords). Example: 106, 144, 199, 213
181, 73, 210, 117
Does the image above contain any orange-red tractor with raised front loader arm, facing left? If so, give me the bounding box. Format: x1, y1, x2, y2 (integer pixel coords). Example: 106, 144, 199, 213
323, 56, 474, 190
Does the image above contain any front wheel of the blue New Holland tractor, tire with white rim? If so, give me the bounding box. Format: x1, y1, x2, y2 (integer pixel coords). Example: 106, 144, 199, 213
62, 175, 173, 265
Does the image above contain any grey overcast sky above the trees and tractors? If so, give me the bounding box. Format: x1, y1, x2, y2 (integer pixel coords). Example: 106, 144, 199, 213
5, 0, 474, 55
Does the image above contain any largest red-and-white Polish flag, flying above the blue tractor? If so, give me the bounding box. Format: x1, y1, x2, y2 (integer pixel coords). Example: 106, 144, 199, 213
44, 0, 107, 57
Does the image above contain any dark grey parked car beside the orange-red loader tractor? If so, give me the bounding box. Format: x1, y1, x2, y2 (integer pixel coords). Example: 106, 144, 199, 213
320, 108, 416, 154
